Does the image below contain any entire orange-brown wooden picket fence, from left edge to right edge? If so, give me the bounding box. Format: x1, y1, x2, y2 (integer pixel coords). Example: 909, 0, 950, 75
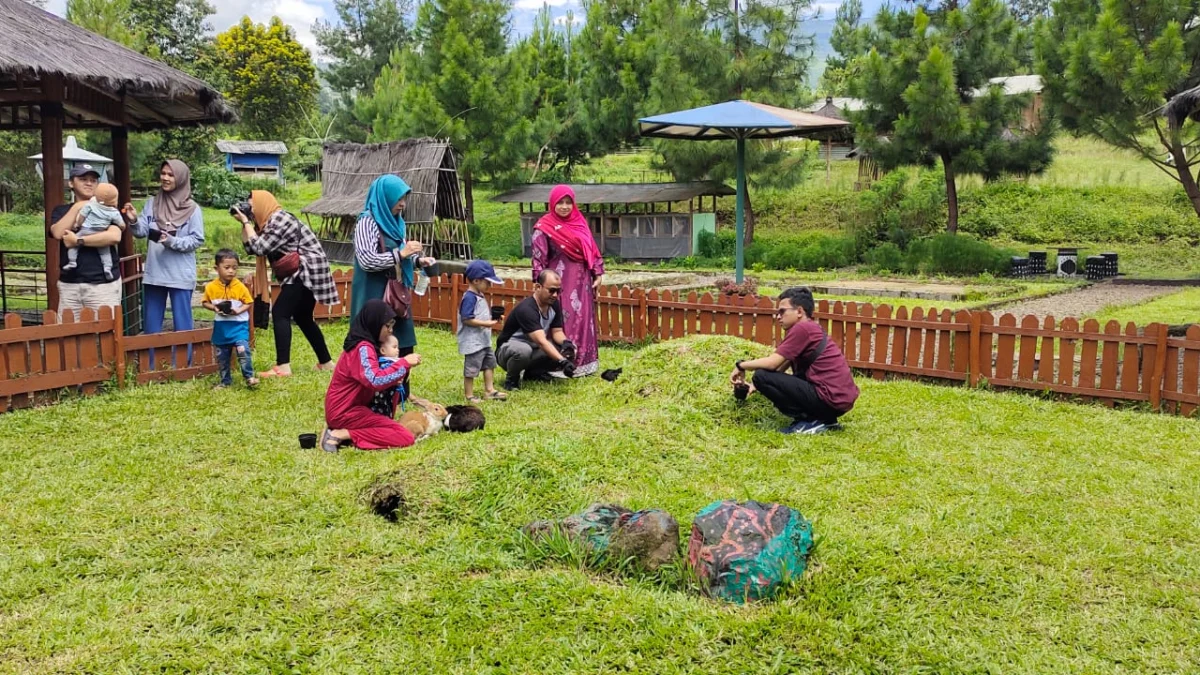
0, 271, 1200, 416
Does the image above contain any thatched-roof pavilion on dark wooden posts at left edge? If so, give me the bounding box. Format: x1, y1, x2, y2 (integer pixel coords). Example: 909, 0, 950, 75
0, 0, 236, 307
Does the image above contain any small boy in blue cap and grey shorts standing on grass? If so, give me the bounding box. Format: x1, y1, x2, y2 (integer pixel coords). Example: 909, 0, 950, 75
457, 261, 508, 404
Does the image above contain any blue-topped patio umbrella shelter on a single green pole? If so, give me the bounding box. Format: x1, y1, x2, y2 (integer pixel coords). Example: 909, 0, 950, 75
637, 101, 850, 278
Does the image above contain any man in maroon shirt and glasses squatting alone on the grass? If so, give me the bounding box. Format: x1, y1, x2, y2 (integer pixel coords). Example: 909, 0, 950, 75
730, 287, 858, 434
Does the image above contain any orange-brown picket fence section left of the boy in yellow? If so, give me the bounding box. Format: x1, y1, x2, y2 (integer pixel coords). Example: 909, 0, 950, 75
0, 307, 217, 412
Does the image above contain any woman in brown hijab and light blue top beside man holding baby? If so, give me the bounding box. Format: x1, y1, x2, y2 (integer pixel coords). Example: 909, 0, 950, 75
121, 160, 204, 333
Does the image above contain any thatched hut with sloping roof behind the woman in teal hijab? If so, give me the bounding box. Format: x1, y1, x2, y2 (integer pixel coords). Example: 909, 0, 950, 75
301, 138, 472, 264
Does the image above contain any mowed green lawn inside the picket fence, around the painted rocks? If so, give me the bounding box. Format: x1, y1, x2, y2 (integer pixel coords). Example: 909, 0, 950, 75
0, 324, 1200, 675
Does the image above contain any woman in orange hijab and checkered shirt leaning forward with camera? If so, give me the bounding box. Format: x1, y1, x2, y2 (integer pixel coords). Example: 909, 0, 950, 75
230, 190, 340, 377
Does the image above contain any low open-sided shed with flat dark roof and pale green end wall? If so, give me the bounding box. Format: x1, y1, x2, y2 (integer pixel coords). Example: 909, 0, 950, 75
494, 181, 736, 261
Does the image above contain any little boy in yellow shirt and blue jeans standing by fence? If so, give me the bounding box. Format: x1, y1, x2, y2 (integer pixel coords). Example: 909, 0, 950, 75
203, 249, 258, 388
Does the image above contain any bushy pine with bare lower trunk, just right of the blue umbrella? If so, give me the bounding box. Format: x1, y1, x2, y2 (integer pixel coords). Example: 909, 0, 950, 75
854, 0, 1054, 233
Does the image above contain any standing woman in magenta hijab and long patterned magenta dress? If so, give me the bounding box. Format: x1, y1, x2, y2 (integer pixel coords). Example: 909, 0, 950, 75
533, 185, 604, 377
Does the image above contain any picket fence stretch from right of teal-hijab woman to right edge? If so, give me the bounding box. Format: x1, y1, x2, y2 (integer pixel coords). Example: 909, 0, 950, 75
396, 275, 1200, 416
